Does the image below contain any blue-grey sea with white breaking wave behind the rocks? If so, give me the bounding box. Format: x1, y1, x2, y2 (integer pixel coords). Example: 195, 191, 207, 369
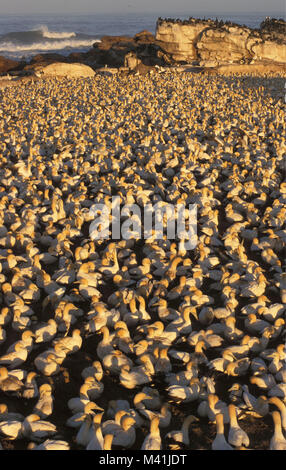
0, 12, 283, 60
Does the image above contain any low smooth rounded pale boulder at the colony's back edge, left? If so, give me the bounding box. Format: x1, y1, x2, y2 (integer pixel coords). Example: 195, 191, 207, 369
38, 62, 95, 78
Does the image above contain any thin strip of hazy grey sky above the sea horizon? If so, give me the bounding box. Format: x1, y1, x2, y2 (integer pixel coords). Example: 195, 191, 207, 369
0, 0, 286, 15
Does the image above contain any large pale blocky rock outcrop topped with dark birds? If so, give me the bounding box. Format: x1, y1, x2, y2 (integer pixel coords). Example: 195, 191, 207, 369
156, 18, 286, 66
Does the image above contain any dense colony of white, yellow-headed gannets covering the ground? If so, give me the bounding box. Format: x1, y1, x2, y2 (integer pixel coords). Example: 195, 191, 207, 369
0, 69, 286, 450
